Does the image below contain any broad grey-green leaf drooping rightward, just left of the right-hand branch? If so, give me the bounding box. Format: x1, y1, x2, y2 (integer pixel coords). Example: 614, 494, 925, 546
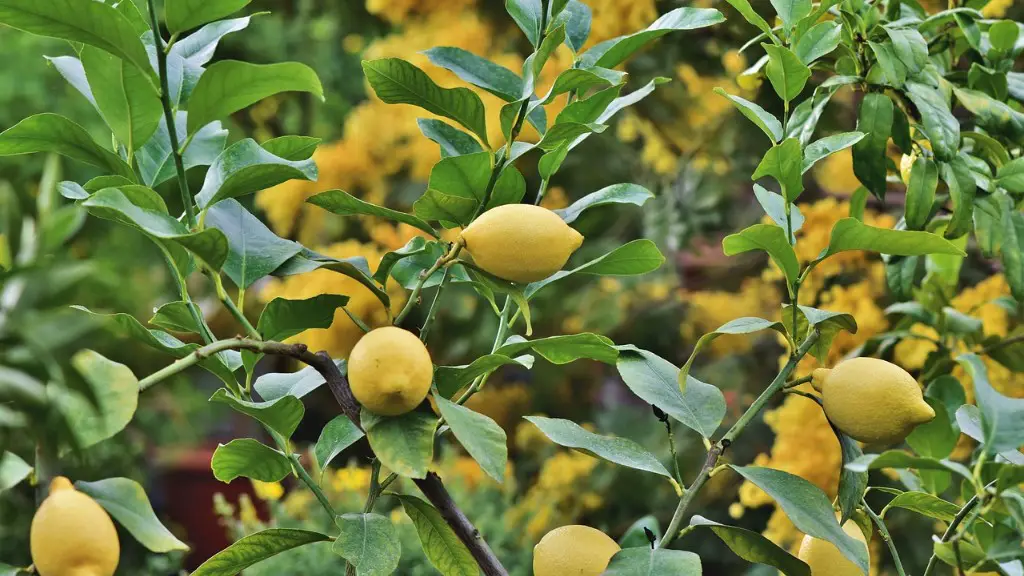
615, 345, 726, 438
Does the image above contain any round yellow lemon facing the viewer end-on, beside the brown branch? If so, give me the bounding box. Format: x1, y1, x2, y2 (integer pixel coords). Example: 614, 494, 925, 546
348, 326, 434, 416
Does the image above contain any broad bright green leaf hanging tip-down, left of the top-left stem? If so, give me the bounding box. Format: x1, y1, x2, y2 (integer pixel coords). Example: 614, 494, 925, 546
81, 46, 163, 151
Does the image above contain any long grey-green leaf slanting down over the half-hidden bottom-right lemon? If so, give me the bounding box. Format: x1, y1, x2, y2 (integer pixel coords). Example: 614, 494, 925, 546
729, 464, 868, 574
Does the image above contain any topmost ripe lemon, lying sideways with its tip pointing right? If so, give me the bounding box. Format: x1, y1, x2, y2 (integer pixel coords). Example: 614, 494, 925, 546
461, 204, 583, 284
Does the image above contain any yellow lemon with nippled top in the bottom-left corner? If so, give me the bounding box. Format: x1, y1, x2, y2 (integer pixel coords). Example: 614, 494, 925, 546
31, 477, 121, 576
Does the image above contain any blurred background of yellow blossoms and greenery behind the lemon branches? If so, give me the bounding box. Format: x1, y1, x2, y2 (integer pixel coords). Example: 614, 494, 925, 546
0, 0, 1024, 576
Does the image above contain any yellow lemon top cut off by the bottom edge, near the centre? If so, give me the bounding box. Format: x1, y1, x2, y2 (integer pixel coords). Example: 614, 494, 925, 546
534, 525, 620, 576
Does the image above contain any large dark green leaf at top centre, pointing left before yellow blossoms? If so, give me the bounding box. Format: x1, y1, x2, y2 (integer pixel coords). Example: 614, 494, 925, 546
364, 57, 487, 145
